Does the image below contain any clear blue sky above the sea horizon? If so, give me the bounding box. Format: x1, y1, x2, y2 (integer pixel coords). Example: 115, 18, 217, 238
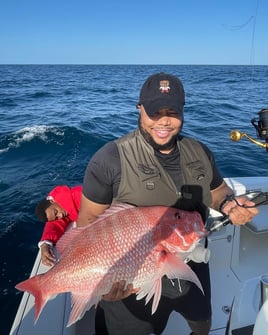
0, 0, 268, 65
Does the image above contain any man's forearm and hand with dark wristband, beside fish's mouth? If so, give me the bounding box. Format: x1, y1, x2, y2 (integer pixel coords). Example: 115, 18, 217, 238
211, 181, 259, 225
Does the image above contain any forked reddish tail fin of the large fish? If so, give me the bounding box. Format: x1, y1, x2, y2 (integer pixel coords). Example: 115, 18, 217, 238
15, 274, 49, 323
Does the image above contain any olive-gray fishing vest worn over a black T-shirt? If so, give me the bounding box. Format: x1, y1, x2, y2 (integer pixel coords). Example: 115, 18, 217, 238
113, 130, 212, 207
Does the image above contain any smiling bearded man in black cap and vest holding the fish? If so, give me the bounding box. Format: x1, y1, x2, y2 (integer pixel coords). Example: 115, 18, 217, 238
77, 73, 258, 335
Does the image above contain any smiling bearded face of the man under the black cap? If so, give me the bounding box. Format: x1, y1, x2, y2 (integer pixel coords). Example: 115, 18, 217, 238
139, 105, 182, 153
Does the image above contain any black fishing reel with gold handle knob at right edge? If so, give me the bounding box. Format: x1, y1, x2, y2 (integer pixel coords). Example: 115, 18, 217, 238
230, 109, 268, 152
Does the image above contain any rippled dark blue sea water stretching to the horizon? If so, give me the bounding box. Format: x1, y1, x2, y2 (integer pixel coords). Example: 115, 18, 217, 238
0, 65, 268, 335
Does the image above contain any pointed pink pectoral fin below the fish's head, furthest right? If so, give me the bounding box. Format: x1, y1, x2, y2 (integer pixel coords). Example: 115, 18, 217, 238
163, 253, 204, 294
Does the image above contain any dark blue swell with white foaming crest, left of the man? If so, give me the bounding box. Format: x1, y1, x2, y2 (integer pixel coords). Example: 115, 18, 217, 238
0, 126, 109, 214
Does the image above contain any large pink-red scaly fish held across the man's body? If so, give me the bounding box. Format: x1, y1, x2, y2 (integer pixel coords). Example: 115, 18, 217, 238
16, 204, 206, 327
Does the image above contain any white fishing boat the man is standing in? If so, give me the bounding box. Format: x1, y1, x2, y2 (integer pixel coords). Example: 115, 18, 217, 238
10, 110, 268, 335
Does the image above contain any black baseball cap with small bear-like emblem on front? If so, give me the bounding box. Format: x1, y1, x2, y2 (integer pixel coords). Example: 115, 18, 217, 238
139, 72, 185, 116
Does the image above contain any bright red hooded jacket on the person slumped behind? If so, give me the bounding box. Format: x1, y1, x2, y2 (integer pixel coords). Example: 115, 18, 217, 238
41, 185, 82, 245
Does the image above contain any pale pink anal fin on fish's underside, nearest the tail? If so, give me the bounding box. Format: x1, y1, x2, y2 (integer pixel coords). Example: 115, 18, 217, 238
67, 291, 101, 327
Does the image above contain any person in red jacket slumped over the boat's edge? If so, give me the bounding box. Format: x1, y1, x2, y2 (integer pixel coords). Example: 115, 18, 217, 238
35, 185, 82, 266
